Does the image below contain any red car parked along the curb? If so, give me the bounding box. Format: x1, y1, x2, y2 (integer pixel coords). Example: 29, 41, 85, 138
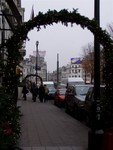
54, 88, 66, 107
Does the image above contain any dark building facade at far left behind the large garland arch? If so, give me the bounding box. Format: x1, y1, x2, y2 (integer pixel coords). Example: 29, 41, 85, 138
0, 0, 26, 82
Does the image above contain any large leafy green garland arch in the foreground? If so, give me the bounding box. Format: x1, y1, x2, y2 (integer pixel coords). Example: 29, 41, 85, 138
1, 9, 113, 112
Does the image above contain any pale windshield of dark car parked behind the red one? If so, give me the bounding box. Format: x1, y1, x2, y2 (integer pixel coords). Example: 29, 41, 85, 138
75, 86, 90, 95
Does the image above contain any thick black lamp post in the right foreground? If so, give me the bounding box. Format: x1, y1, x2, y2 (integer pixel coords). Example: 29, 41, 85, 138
88, 0, 104, 150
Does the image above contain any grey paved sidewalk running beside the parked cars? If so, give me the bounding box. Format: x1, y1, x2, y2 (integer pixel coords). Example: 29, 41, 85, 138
18, 93, 89, 150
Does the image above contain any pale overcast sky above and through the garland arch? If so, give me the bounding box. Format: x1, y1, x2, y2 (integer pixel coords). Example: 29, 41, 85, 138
21, 0, 113, 72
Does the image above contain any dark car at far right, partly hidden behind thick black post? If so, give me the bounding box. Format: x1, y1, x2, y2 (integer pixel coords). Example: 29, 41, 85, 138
83, 85, 105, 126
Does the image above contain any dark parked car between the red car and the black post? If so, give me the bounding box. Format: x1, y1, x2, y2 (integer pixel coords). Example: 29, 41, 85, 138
65, 84, 93, 119
